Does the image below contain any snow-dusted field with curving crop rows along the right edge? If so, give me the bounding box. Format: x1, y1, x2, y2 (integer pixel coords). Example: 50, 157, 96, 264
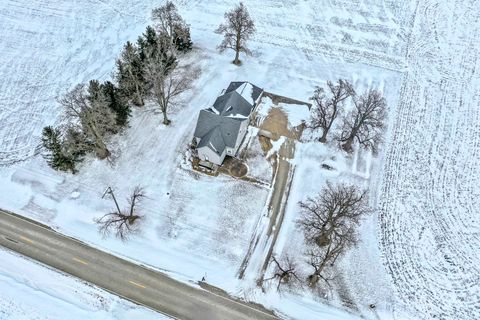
378, 0, 480, 319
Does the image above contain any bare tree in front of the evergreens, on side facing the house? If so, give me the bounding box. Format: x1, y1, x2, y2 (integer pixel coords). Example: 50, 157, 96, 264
145, 46, 198, 125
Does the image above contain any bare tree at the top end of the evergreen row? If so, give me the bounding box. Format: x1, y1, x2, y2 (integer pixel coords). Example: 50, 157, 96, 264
152, 1, 188, 53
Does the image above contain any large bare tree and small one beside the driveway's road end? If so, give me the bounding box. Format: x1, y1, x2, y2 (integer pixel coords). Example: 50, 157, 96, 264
265, 183, 370, 289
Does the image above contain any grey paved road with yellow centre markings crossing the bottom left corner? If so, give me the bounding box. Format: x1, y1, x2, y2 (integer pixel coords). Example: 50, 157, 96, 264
0, 210, 278, 320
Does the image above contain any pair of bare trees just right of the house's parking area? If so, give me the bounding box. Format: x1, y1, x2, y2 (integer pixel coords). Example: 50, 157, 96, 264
310, 80, 387, 152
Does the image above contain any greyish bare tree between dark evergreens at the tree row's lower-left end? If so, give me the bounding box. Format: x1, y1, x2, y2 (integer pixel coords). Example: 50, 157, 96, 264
60, 84, 118, 159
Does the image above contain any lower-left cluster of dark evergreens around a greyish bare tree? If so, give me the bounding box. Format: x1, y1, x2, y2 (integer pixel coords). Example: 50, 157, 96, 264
42, 80, 131, 173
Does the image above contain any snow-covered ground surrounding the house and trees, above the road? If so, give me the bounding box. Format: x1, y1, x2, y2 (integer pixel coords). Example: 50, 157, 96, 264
0, 0, 480, 320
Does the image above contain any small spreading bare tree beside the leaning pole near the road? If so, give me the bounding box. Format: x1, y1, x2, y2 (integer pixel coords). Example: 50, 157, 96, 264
95, 187, 145, 241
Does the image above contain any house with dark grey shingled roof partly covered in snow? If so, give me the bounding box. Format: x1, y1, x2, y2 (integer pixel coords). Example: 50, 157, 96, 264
194, 81, 263, 165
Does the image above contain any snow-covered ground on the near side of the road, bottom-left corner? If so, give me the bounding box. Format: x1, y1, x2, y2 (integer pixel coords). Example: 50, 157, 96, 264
0, 248, 170, 320
